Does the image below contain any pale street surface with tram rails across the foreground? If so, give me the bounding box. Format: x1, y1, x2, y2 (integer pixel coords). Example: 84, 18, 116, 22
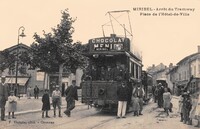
0, 97, 197, 129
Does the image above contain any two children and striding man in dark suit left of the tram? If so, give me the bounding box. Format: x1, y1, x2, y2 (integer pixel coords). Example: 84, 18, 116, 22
42, 80, 78, 118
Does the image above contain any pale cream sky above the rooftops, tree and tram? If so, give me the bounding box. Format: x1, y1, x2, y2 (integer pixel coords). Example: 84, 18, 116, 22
0, 0, 200, 69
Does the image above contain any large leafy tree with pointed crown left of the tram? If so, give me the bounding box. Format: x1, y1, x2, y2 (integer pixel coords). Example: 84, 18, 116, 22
31, 9, 87, 86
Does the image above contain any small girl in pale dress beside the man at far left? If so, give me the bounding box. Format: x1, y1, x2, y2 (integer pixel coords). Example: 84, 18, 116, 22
8, 91, 17, 119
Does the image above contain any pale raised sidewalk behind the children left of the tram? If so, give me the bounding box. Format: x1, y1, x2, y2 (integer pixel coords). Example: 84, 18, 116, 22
5, 97, 83, 116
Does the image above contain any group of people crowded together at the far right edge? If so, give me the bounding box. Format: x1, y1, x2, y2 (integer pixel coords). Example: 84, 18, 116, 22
178, 90, 200, 128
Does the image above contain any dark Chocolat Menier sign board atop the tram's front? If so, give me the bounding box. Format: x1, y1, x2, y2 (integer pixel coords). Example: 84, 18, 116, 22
89, 37, 129, 51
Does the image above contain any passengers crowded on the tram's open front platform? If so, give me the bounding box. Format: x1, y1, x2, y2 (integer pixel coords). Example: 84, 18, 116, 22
82, 62, 126, 81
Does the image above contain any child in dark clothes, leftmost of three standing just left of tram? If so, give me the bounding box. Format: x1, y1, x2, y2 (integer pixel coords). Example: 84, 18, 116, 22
42, 89, 50, 118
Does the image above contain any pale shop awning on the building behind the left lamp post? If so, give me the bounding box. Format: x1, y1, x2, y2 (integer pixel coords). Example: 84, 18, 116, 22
6, 77, 29, 86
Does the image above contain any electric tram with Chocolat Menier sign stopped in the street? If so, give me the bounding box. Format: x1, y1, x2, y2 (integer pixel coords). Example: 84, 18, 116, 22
81, 34, 143, 111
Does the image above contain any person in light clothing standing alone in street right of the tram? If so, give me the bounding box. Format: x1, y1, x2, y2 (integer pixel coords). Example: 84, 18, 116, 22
163, 88, 172, 116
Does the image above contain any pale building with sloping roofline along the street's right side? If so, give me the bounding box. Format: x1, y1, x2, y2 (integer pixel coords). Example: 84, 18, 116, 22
167, 46, 200, 94
